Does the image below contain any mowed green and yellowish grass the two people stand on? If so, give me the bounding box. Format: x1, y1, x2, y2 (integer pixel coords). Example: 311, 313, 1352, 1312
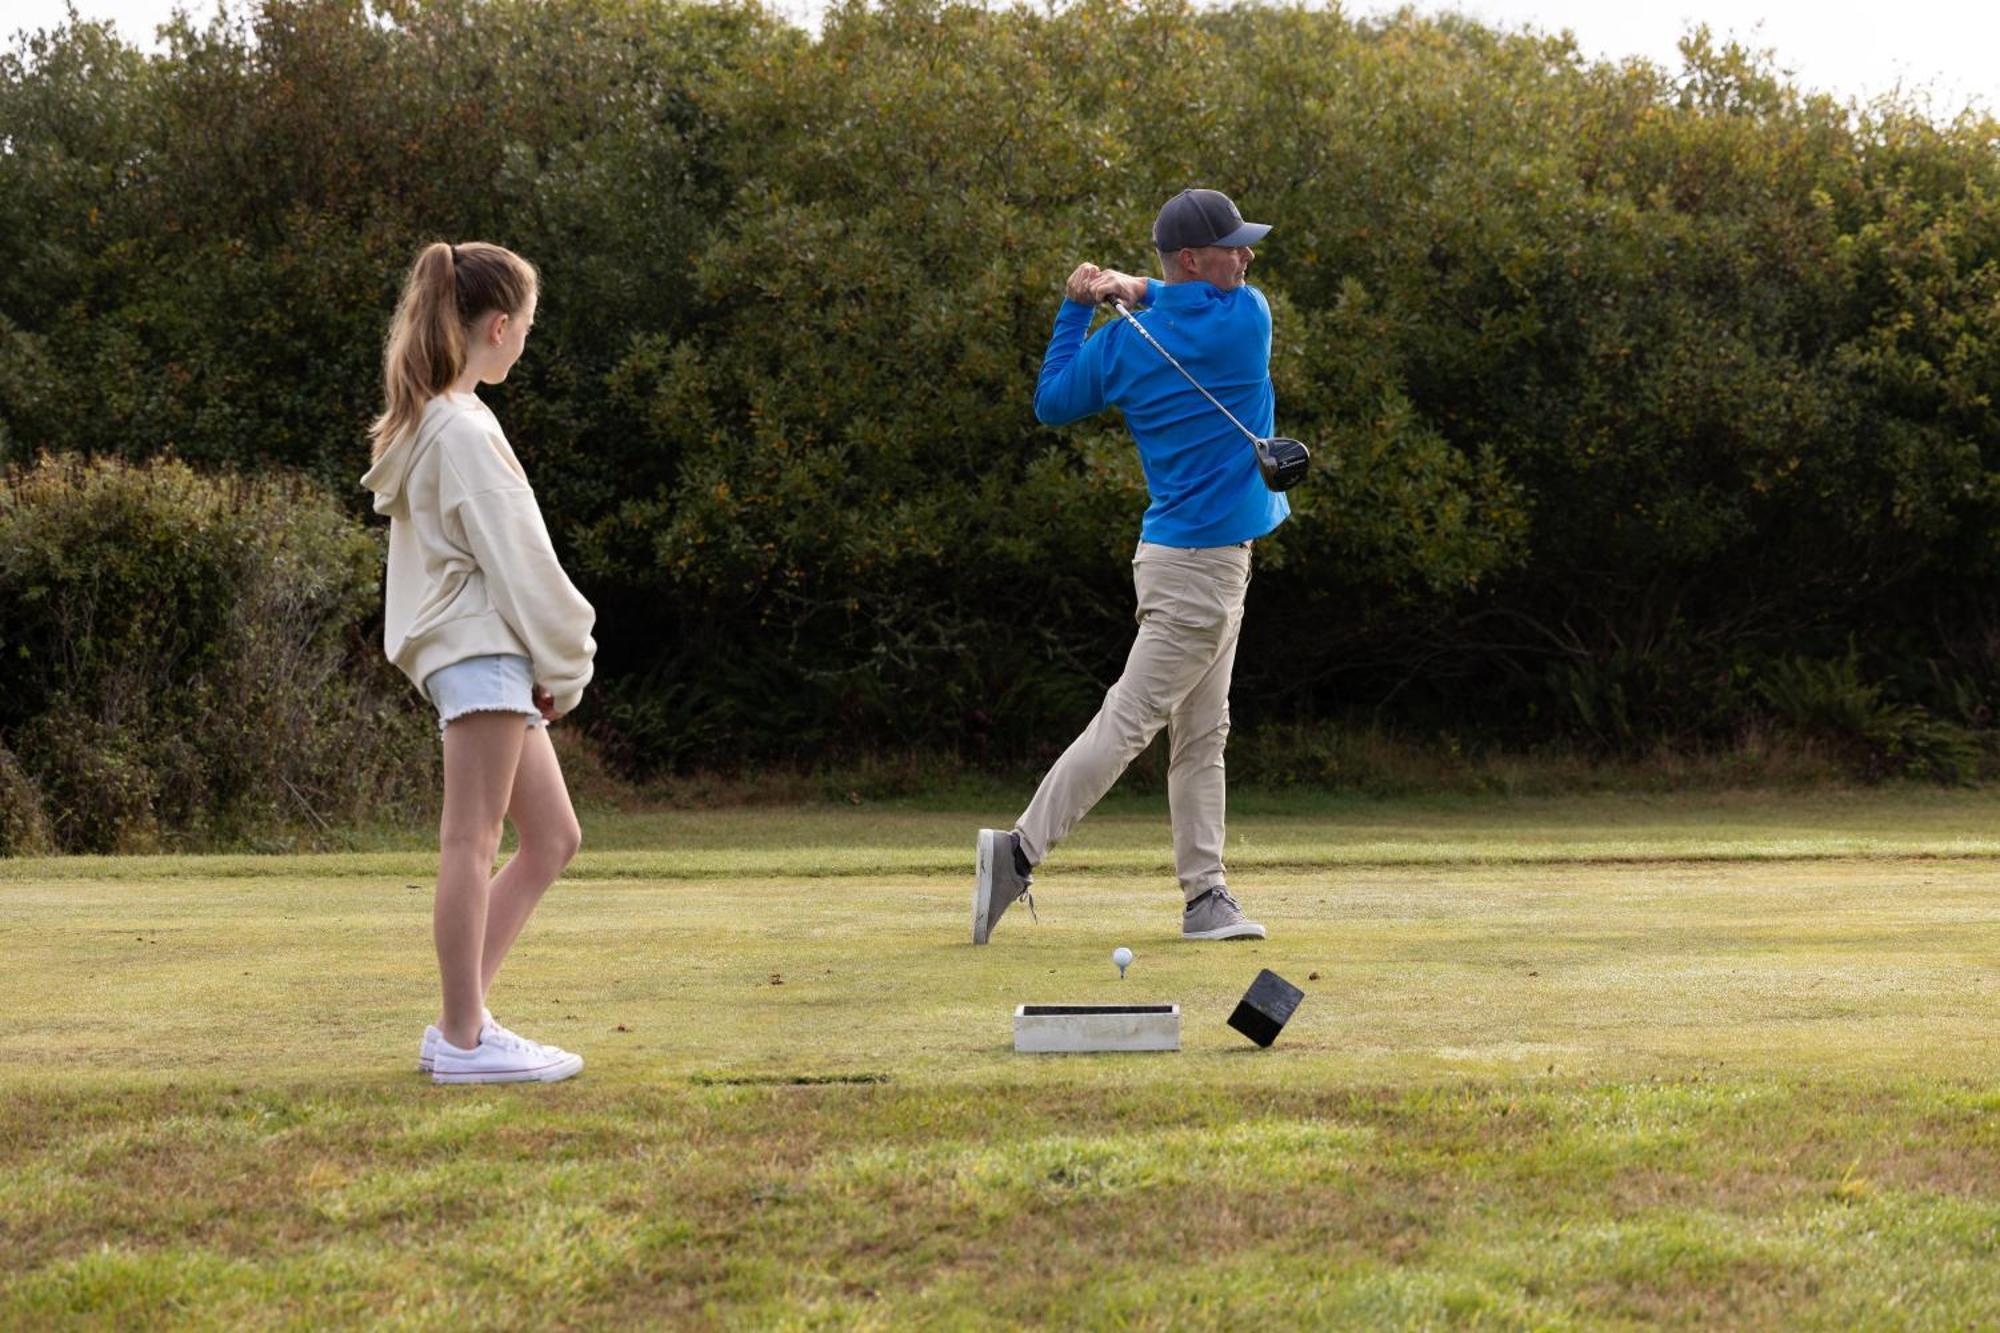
0, 793, 2000, 1329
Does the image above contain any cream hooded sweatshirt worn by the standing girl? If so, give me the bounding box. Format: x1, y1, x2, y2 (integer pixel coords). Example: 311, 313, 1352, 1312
362, 392, 598, 713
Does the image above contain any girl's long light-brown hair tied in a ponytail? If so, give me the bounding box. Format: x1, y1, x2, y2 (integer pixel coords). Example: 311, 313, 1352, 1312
368, 240, 540, 458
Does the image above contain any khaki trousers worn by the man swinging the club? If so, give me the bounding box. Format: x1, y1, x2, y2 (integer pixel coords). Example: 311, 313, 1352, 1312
1016, 542, 1250, 903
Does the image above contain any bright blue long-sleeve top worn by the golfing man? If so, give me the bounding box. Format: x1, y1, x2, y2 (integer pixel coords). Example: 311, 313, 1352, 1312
1034, 280, 1292, 546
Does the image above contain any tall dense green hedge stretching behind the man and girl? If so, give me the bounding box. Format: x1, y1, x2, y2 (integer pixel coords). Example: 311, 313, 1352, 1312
0, 0, 2000, 773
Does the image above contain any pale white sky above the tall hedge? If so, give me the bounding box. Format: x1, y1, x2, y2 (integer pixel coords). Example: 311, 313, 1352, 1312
11, 0, 2000, 116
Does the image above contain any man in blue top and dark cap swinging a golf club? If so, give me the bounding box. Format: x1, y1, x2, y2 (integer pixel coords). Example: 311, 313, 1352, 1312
972, 190, 1304, 945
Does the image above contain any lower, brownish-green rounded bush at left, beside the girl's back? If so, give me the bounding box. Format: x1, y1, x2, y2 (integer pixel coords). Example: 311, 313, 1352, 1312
0, 458, 436, 851
